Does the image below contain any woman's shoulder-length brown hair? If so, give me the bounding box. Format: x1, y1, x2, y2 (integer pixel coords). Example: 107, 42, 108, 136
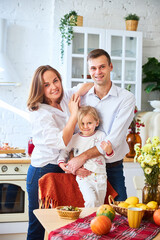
27, 65, 63, 111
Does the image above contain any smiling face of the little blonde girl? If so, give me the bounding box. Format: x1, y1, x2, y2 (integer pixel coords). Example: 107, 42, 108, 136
80, 114, 99, 136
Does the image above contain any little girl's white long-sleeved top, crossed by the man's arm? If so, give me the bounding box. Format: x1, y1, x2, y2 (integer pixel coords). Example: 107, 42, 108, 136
58, 130, 106, 175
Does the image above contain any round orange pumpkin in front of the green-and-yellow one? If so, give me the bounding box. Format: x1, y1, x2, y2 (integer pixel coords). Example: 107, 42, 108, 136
90, 215, 112, 235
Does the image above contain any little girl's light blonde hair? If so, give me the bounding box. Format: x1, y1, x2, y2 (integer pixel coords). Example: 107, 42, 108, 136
78, 106, 100, 128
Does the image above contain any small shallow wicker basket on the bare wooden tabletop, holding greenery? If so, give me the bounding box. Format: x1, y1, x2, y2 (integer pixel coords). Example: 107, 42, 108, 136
56, 206, 82, 219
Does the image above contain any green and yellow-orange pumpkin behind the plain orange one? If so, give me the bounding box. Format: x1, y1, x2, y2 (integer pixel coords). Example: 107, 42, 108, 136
96, 204, 115, 221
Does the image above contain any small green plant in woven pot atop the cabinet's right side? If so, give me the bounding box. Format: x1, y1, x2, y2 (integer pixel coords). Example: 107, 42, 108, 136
124, 13, 139, 31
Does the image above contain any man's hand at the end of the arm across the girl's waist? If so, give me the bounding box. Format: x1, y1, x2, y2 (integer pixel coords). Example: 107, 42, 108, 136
67, 155, 85, 175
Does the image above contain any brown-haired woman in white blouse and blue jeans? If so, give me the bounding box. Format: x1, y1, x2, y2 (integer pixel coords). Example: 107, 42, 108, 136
27, 65, 93, 240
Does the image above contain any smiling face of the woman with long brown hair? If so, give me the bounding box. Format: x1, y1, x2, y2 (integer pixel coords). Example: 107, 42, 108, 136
43, 70, 62, 106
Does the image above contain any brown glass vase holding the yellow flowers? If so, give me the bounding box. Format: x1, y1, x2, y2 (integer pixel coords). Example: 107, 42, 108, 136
142, 183, 160, 205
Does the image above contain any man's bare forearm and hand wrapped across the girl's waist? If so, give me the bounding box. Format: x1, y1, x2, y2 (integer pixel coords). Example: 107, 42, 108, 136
68, 147, 101, 174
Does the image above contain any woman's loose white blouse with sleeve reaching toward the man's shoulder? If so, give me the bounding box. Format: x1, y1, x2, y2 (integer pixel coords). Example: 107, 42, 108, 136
29, 86, 79, 167
